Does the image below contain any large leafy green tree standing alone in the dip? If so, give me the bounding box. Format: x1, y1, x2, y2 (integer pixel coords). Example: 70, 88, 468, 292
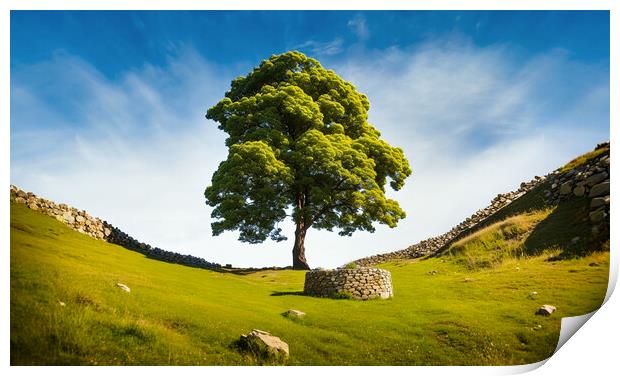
205, 51, 411, 269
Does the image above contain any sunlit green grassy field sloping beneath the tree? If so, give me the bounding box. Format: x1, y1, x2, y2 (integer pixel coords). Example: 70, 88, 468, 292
11, 203, 609, 365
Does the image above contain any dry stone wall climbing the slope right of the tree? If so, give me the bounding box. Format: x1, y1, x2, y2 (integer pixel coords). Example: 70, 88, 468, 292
354, 142, 610, 266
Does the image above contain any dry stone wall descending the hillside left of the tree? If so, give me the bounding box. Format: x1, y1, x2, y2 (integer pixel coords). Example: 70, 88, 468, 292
11, 185, 221, 269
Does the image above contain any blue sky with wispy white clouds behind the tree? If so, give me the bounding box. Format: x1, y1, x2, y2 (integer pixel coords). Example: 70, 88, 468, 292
10, 11, 610, 267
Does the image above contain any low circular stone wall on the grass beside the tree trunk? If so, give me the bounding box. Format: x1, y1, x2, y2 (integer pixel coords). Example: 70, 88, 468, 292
304, 268, 393, 300
